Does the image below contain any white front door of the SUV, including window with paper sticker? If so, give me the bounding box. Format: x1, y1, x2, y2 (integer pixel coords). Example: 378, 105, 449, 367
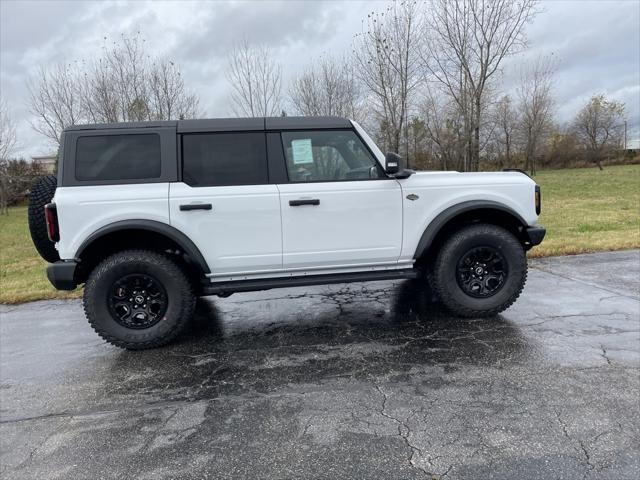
278, 130, 402, 270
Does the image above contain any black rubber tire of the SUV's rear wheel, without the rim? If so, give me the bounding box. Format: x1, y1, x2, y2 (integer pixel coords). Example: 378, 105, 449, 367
83, 250, 196, 350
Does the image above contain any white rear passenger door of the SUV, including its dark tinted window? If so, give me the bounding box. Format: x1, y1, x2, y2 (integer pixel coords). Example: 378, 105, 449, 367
169, 131, 282, 278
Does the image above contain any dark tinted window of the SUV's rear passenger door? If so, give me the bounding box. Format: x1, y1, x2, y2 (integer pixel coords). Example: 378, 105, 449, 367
182, 132, 269, 187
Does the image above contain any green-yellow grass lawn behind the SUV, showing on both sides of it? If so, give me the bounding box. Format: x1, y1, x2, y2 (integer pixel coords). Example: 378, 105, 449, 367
0, 165, 640, 304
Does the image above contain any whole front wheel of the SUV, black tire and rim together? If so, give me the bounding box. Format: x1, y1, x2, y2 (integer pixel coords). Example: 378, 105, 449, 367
431, 224, 527, 317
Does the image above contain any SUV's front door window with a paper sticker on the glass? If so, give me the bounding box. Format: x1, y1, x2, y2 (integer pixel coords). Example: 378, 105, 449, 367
282, 130, 383, 182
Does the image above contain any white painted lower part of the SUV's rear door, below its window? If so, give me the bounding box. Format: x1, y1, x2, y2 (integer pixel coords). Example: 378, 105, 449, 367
169, 182, 282, 277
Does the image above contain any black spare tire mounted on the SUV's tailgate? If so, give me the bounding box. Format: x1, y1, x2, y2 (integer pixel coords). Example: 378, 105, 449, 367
29, 175, 60, 263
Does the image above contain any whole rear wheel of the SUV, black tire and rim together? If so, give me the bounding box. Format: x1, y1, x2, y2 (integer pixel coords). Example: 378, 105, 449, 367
84, 250, 196, 350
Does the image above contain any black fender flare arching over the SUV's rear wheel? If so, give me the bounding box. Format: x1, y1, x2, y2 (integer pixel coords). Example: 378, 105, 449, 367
75, 220, 211, 274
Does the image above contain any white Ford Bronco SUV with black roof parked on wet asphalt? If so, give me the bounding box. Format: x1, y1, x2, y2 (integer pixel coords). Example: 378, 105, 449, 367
29, 117, 545, 349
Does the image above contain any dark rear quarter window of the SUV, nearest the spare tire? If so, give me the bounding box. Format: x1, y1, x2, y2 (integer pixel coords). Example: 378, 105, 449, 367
76, 134, 161, 180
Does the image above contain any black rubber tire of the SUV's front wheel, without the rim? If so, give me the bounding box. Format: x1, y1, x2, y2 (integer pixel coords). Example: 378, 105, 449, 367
431, 223, 527, 317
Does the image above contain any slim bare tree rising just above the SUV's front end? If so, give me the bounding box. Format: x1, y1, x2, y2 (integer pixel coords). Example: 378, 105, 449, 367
518, 58, 554, 175
